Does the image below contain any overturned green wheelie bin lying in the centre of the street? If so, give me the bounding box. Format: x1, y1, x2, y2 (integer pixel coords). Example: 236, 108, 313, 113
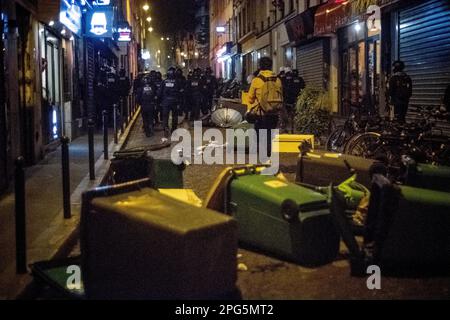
225, 167, 340, 266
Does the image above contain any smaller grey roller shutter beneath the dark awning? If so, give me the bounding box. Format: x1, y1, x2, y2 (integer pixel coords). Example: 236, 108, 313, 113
297, 40, 325, 88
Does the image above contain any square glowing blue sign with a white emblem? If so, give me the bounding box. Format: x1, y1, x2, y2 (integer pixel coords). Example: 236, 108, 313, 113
85, 7, 114, 38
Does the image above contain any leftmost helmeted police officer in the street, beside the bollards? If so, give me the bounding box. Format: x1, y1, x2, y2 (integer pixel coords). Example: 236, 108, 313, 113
138, 75, 158, 137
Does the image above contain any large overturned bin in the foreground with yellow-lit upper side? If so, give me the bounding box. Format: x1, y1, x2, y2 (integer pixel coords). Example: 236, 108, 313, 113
81, 182, 238, 300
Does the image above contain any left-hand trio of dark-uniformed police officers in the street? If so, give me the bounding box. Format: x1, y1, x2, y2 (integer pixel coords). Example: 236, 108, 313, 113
134, 67, 218, 138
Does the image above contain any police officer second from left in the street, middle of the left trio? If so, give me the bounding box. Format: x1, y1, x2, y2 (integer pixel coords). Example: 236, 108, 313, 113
158, 67, 183, 138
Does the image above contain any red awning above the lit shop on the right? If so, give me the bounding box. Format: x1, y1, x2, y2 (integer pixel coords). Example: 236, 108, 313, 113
314, 0, 352, 36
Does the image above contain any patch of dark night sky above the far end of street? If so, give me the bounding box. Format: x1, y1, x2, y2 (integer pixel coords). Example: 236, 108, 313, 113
151, 0, 195, 35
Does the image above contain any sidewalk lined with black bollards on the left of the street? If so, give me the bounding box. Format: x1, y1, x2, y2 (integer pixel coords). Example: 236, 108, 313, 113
0, 110, 138, 299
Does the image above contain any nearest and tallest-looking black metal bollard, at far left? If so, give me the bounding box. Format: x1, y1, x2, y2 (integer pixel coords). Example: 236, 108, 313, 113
15, 157, 27, 274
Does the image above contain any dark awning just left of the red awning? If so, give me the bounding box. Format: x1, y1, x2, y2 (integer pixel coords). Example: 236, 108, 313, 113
286, 6, 319, 43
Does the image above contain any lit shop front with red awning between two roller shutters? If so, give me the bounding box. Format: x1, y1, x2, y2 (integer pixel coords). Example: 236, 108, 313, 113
314, 1, 382, 116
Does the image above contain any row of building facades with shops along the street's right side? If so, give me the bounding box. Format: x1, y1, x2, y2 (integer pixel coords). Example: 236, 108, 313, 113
210, 0, 450, 126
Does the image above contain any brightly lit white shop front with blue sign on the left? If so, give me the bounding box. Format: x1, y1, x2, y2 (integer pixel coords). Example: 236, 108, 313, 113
39, 0, 83, 145
